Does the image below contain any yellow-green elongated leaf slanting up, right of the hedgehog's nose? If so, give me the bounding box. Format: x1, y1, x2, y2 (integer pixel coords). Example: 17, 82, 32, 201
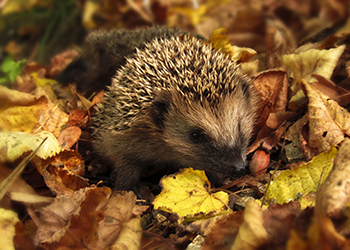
266, 146, 337, 208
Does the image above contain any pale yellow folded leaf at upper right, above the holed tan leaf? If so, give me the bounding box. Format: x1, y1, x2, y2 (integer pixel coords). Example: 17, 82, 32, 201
283, 45, 345, 107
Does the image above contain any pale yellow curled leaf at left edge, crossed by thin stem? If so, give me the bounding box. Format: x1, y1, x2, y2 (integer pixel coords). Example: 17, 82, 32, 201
0, 131, 61, 162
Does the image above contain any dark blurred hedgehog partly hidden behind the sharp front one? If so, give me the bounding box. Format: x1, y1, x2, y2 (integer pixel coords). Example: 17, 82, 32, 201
56, 27, 189, 93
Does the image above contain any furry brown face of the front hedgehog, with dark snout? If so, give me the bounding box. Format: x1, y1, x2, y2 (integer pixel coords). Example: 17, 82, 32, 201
154, 88, 254, 179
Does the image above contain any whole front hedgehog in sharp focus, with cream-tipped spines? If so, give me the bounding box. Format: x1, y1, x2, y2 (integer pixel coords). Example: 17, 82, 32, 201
93, 35, 257, 190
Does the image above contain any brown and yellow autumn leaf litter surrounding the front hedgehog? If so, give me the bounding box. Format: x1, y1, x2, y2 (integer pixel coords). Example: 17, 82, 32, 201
0, 0, 350, 249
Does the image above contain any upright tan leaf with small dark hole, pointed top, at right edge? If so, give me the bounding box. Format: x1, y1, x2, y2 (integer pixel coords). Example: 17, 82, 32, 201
303, 82, 350, 152
